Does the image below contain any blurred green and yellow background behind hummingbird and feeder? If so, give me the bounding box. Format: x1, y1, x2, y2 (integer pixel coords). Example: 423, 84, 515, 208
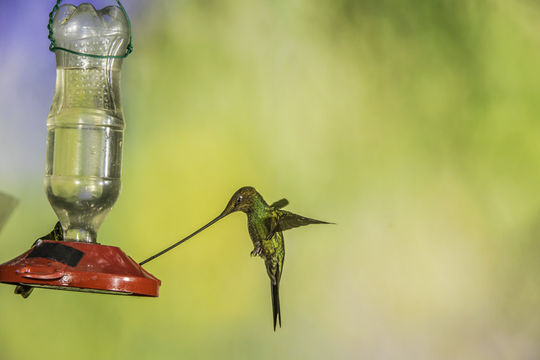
0, 0, 540, 360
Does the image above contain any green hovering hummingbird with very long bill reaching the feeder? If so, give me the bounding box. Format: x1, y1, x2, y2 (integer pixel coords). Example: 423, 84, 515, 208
140, 186, 332, 331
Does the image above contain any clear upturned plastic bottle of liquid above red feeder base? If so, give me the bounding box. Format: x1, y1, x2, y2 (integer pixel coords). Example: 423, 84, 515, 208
45, 4, 129, 242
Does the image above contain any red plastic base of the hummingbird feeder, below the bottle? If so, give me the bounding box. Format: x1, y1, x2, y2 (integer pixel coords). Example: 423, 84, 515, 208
0, 240, 161, 297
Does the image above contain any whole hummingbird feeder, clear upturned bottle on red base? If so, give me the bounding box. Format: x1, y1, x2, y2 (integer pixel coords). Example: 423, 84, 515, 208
0, 1, 161, 296
